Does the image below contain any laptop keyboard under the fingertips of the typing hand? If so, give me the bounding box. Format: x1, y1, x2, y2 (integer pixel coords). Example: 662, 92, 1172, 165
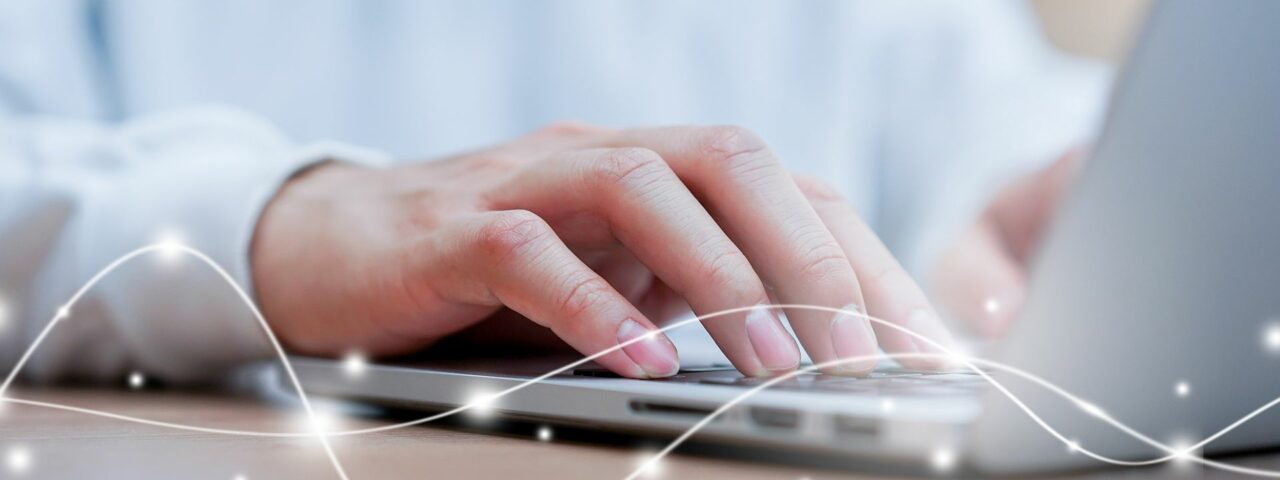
573, 365, 987, 396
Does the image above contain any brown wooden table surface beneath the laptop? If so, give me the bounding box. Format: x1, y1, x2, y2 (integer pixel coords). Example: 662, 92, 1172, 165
0, 388, 1264, 480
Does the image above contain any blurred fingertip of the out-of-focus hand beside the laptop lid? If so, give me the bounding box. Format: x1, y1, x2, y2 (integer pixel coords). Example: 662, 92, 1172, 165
934, 215, 1027, 338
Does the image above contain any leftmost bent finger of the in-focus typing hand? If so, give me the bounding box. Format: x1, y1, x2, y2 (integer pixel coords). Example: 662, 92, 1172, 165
425, 210, 680, 378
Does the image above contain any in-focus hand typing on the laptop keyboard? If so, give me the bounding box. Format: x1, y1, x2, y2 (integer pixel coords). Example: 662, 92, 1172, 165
251, 124, 950, 378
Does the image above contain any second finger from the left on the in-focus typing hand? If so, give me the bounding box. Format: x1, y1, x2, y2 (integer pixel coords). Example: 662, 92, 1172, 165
497, 148, 800, 375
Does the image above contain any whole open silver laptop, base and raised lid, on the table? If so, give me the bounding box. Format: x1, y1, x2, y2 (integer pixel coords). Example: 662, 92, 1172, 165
264, 0, 1280, 474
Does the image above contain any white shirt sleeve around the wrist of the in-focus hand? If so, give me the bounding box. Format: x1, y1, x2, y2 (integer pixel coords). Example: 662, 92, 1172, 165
0, 108, 384, 383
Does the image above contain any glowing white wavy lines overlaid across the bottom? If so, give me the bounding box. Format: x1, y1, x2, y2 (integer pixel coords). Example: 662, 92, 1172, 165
0, 242, 1280, 480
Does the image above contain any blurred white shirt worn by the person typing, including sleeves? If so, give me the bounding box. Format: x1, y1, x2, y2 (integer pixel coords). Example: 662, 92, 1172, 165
0, 0, 1106, 381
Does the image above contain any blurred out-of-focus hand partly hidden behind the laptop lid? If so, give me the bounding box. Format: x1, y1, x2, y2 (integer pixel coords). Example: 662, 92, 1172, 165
934, 152, 1079, 338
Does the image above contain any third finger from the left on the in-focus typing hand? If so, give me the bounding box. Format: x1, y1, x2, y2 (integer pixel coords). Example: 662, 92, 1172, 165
611, 127, 877, 374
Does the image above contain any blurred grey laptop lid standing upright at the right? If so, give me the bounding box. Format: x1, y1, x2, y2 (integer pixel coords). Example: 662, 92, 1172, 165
968, 0, 1280, 471
